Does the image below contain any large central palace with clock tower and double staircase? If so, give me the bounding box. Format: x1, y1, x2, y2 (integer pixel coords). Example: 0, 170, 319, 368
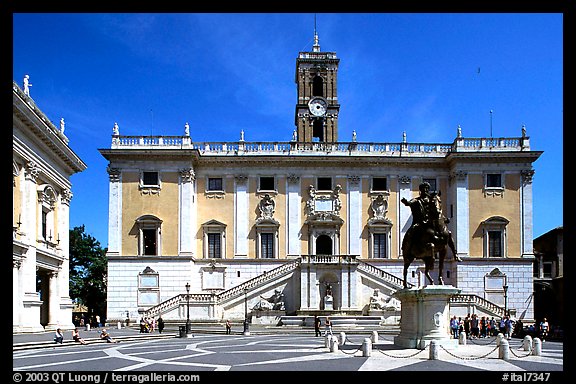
99, 36, 542, 322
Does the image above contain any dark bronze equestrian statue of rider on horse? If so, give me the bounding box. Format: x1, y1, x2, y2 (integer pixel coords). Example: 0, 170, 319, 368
402, 188, 462, 288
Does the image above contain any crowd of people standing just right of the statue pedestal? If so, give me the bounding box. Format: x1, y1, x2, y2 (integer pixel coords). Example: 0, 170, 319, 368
450, 313, 514, 339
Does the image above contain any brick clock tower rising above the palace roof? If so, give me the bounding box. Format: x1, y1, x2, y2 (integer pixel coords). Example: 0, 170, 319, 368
295, 31, 340, 142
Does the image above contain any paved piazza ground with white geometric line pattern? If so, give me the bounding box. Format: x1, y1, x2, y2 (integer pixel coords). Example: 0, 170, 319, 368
13, 334, 563, 382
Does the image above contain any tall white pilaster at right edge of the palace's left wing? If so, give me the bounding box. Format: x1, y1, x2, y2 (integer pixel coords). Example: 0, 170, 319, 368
178, 168, 196, 256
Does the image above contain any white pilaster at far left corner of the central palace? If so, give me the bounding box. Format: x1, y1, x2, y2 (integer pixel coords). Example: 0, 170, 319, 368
106, 167, 122, 256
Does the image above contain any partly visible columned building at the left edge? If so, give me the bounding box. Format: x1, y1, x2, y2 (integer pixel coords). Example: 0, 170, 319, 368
12, 76, 86, 333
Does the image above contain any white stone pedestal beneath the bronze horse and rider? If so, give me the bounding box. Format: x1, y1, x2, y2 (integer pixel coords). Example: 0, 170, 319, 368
394, 285, 461, 349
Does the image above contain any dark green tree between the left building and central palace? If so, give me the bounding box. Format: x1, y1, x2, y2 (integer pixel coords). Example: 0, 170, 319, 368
70, 225, 108, 320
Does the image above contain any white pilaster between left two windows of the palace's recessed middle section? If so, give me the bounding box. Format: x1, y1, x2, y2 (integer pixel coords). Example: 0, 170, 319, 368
234, 175, 249, 259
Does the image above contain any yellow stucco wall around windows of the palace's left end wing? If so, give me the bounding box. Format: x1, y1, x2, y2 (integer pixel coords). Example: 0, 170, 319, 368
121, 172, 179, 255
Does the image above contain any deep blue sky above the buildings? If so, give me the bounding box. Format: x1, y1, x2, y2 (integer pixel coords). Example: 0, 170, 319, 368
12, 13, 563, 247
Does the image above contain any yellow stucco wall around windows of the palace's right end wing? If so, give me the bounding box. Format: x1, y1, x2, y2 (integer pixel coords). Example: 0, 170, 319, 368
468, 174, 521, 257
